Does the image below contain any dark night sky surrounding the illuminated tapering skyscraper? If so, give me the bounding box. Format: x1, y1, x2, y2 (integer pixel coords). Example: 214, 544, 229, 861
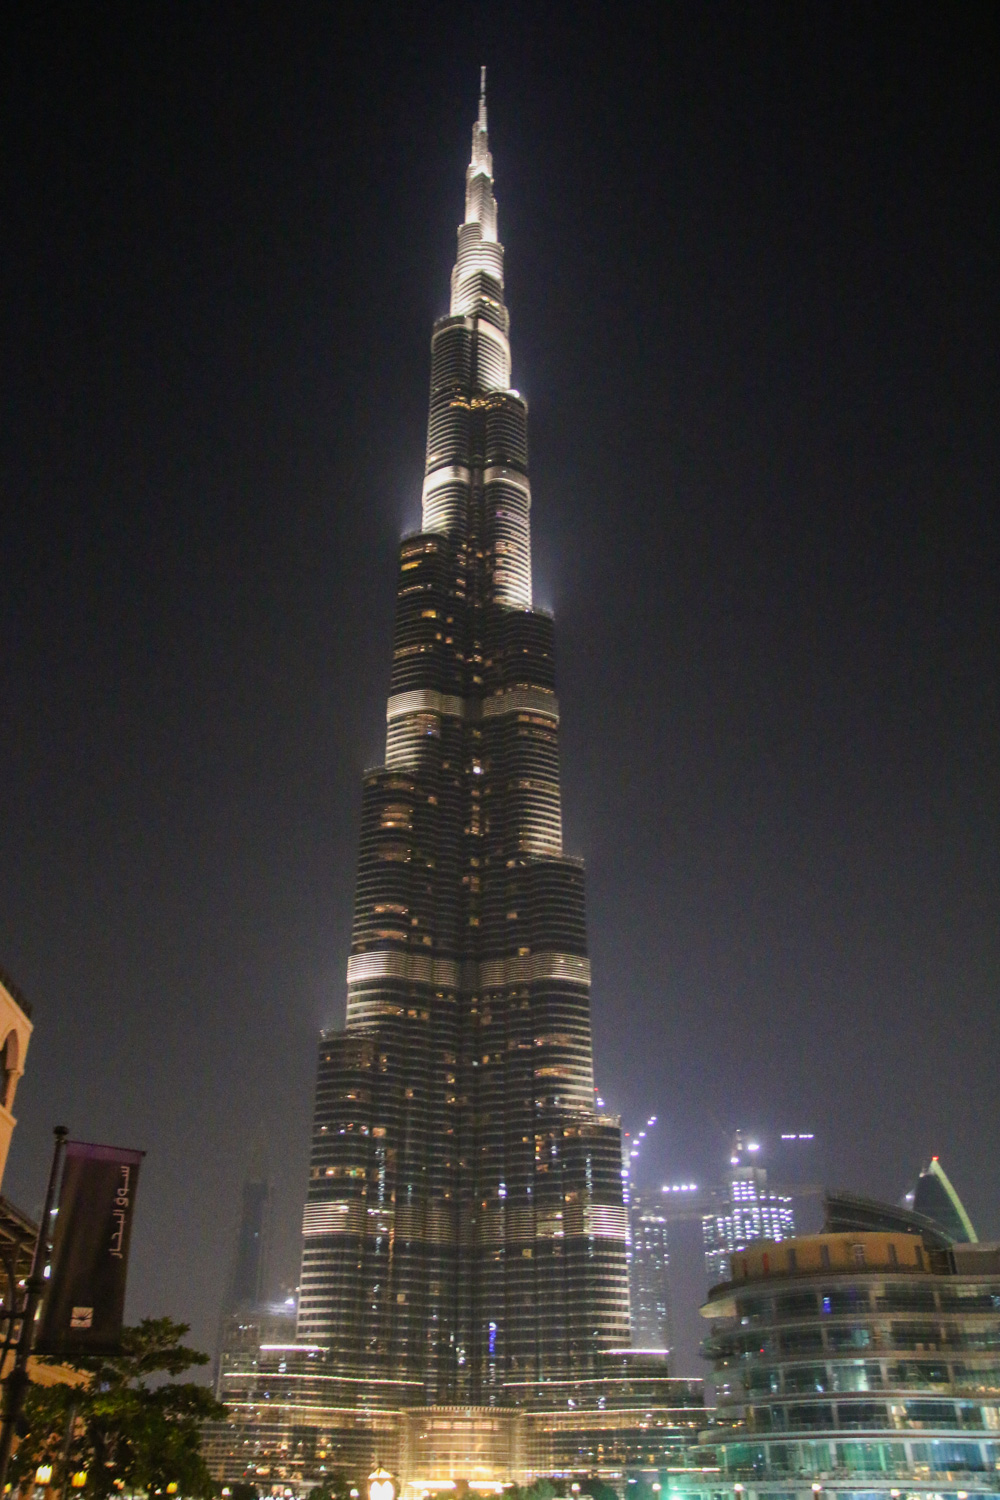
0, 0, 1000, 1368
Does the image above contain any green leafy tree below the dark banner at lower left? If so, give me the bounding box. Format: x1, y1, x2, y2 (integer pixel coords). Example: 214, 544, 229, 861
9, 1317, 225, 1500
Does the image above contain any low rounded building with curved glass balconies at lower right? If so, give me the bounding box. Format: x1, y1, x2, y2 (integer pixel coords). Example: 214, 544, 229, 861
702, 1233, 1000, 1500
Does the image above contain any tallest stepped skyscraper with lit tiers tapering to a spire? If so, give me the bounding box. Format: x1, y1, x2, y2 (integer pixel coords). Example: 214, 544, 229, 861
298, 70, 628, 1406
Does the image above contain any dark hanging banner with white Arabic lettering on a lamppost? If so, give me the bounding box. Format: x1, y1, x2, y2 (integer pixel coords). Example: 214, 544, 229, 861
34, 1140, 145, 1356
